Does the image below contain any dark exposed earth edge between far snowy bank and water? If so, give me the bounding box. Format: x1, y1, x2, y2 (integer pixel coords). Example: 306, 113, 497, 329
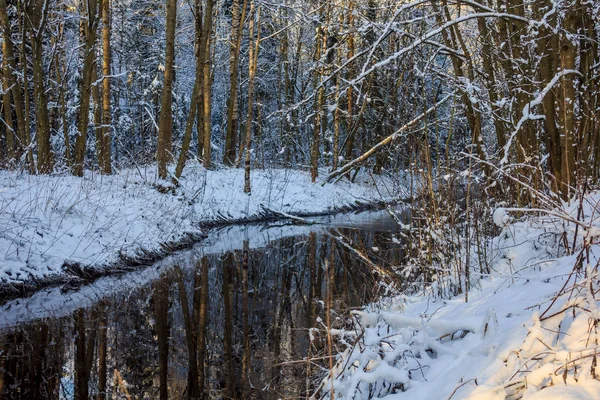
0, 198, 407, 304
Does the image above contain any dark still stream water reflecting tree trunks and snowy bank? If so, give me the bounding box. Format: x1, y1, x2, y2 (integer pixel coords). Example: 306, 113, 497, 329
0, 212, 402, 399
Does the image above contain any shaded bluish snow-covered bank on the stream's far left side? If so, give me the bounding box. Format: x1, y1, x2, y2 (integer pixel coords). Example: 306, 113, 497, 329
0, 166, 401, 287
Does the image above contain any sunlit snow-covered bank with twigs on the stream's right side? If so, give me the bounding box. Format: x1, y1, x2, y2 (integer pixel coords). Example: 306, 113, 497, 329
321, 192, 600, 400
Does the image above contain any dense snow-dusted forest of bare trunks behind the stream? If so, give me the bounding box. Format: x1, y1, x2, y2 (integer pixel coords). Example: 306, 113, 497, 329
0, 0, 600, 197
